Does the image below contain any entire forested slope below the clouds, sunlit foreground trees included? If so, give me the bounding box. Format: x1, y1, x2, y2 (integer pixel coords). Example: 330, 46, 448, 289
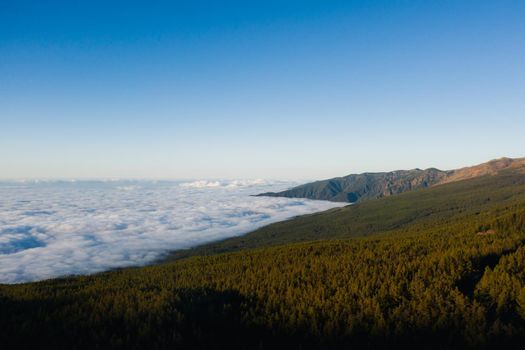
0, 171, 525, 349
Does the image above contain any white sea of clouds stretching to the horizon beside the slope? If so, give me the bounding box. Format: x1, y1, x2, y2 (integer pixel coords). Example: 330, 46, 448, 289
0, 180, 343, 283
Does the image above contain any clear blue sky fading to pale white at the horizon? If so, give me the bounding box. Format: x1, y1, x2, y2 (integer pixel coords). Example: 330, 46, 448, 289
0, 0, 525, 179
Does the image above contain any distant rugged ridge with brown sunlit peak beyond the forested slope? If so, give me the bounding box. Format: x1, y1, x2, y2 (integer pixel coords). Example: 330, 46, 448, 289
258, 158, 525, 203
